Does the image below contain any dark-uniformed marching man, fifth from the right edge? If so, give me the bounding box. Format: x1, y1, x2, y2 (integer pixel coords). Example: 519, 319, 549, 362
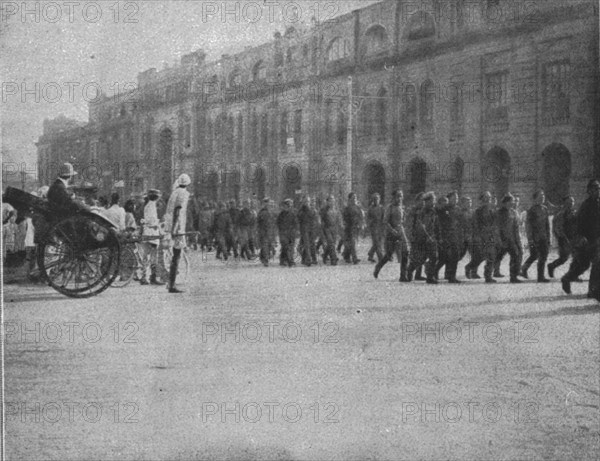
465, 191, 500, 283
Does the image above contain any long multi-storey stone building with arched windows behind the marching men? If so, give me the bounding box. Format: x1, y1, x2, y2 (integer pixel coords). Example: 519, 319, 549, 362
38, 0, 600, 203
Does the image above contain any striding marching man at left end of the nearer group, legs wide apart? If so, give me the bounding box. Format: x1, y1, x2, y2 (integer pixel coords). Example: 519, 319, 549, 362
373, 190, 409, 282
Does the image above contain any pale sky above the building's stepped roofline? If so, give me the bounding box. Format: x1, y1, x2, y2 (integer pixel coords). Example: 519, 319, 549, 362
0, 0, 380, 168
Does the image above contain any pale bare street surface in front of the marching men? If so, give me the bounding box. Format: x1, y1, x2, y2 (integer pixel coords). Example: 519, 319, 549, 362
4, 252, 600, 460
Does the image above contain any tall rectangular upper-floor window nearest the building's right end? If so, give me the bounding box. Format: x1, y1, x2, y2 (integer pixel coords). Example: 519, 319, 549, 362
542, 60, 571, 126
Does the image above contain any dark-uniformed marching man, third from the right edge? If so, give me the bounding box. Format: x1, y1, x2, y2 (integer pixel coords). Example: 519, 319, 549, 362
520, 190, 550, 283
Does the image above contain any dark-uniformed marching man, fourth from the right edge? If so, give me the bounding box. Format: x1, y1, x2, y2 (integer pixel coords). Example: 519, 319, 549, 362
497, 194, 523, 283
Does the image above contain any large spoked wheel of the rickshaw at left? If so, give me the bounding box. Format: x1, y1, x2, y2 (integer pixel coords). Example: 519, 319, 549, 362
37, 215, 120, 298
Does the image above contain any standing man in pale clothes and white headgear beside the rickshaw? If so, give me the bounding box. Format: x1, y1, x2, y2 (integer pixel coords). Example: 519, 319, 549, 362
164, 173, 192, 293
